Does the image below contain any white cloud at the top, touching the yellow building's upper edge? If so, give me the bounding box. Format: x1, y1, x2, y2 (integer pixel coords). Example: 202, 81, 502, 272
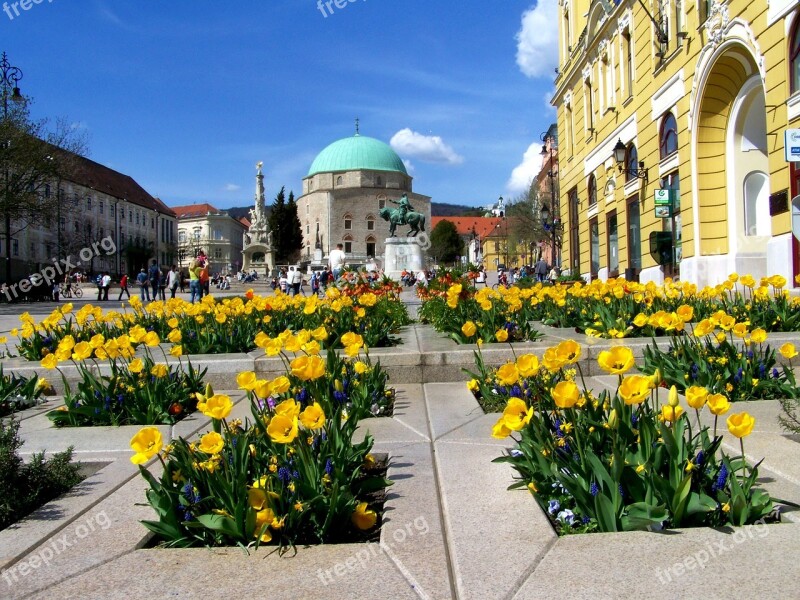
517, 0, 558, 77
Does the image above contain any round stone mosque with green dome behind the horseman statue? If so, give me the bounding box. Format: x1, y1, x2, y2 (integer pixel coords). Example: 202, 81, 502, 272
297, 123, 431, 268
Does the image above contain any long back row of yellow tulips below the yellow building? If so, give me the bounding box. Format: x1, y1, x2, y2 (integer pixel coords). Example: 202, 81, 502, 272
419, 272, 800, 343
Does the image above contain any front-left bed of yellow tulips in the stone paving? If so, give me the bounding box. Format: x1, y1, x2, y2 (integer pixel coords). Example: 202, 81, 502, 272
131, 339, 393, 550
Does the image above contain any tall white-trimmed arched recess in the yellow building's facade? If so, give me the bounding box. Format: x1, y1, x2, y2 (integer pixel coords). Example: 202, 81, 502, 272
692, 42, 770, 285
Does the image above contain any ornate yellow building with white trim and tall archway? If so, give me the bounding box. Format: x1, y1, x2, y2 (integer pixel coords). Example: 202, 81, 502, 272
553, 0, 800, 285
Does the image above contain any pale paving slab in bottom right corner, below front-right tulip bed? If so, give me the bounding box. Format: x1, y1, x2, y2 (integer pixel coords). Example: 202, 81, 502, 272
512, 524, 800, 600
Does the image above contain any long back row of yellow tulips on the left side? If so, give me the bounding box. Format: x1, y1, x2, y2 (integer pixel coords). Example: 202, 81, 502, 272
12, 284, 410, 360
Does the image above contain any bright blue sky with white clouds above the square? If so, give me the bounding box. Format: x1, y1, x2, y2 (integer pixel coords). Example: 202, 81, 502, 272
0, 0, 558, 208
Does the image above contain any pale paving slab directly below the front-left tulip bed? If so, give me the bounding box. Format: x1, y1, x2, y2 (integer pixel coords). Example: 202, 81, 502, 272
23, 544, 420, 600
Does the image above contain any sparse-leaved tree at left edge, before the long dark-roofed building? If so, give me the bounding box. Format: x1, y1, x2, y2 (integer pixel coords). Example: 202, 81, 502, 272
0, 85, 86, 280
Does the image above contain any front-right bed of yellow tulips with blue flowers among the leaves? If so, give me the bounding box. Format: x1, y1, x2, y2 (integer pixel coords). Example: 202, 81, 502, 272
469, 341, 773, 534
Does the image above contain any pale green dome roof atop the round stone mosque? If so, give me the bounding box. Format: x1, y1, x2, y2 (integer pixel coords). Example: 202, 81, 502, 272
307, 135, 408, 177
